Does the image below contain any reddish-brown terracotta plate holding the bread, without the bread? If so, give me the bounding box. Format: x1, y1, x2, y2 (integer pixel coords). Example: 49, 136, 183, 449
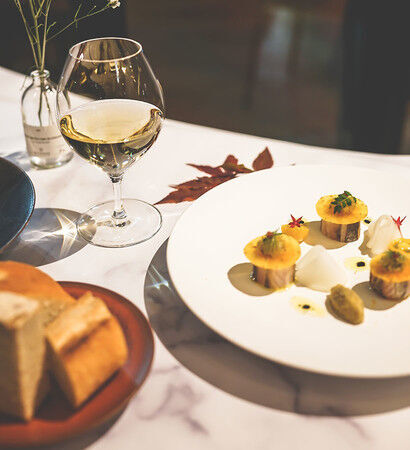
0, 281, 154, 447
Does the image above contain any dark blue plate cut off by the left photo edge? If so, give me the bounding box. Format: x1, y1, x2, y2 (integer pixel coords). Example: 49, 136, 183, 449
0, 158, 36, 251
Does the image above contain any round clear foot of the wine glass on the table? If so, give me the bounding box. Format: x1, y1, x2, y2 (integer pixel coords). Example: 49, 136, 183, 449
77, 198, 162, 248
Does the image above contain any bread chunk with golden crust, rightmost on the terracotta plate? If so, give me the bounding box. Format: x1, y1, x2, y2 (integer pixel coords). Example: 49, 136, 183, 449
46, 292, 128, 407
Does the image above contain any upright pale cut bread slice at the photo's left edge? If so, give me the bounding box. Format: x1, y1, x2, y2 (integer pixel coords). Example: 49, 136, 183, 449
0, 292, 48, 421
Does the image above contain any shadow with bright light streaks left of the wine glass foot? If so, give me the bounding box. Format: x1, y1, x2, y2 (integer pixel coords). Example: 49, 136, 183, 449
0, 208, 87, 266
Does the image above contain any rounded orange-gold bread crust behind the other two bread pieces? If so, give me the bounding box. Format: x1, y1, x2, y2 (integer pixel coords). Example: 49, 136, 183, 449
0, 261, 75, 325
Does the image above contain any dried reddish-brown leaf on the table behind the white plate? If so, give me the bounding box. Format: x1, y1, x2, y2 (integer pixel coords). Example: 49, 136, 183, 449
156, 148, 273, 205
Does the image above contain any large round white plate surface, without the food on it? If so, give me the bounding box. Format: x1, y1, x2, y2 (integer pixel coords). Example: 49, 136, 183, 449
167, 165, 410, 377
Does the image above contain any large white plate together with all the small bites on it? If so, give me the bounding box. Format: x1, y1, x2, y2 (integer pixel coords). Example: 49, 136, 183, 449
167, 166, 410, 377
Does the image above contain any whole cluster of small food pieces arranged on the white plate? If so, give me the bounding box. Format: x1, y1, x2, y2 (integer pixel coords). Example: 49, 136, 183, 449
244, 190, 410, 325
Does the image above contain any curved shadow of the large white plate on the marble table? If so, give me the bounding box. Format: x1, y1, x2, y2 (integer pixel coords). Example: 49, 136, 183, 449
144, 241, 410, 416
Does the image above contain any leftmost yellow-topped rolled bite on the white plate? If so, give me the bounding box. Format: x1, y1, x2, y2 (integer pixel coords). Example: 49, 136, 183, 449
244, 232, 300, 290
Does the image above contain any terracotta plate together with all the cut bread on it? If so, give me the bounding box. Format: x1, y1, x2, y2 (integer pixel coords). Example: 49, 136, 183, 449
0, 263, 153, 447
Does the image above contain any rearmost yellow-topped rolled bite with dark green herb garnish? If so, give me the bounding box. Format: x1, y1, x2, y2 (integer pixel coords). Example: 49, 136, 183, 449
316, 191, 367, 242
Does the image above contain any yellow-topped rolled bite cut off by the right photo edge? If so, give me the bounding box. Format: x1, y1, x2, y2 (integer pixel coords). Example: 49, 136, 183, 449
370, 250, 410, 300
